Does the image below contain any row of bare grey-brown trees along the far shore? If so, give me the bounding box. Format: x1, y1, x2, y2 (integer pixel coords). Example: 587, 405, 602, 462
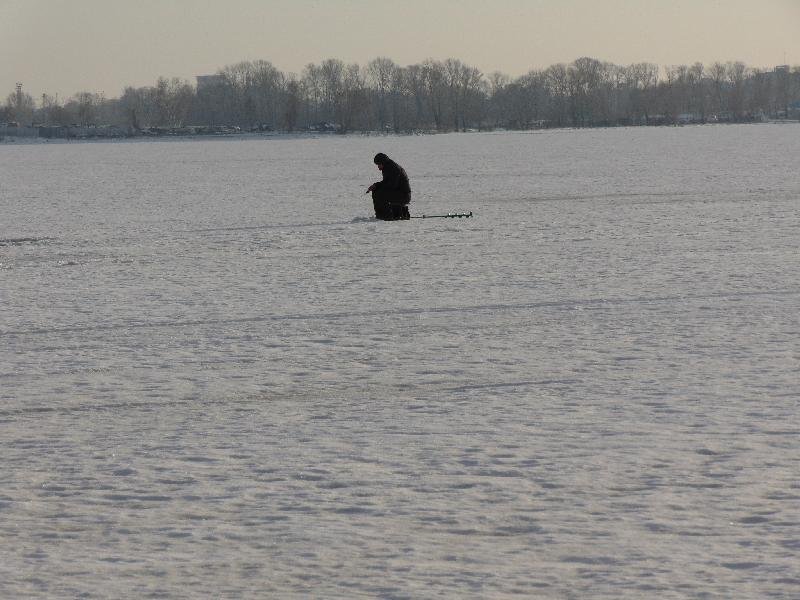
0, 57, 800, 133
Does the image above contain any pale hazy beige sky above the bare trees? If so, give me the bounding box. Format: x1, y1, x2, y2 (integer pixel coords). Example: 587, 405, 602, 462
0, 0, 800, 101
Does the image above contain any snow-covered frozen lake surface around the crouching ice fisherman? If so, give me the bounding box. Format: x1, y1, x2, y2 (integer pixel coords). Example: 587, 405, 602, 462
0, 125, 800, 599
